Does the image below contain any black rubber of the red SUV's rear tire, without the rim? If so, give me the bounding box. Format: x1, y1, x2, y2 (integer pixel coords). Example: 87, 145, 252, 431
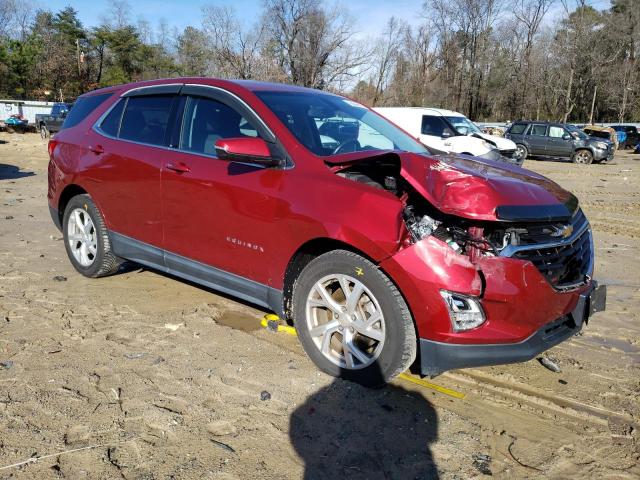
62, 194, 124, 278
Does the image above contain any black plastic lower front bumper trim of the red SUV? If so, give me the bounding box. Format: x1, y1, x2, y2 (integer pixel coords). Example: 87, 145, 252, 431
420, 281, 607, 375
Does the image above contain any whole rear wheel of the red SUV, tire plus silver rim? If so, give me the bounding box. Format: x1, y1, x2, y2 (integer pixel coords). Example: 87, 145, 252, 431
62, 194, 123, 278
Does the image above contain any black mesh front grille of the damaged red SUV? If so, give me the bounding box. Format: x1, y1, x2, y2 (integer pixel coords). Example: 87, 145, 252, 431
513, 219, 592, 289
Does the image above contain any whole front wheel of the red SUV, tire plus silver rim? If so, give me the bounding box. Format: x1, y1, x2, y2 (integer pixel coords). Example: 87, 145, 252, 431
293, 250, 417, 387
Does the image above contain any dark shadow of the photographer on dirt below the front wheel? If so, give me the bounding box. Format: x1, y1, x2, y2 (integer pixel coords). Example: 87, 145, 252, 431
289, 364, 438, 480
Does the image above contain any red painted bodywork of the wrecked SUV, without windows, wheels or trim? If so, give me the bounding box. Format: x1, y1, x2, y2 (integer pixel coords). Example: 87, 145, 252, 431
48, 78, 600, 372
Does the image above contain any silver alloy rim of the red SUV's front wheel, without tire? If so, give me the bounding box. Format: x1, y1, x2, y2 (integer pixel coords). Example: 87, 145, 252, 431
305, 274, 385, 370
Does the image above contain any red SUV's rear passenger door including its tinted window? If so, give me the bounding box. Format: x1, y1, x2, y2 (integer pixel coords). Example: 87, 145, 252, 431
91, 84, 181, 249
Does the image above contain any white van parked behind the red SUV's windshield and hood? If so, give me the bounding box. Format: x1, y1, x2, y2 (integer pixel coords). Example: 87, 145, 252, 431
374, 107, 522, 163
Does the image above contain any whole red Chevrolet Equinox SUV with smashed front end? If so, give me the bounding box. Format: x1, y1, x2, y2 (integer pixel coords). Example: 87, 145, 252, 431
48, 78, 605, 384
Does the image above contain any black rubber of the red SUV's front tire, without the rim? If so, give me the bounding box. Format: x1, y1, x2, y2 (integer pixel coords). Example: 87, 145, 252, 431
293, 250, 417, 387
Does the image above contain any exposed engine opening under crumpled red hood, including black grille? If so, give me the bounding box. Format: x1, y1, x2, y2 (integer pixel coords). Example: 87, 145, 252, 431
334, 156, 590, 288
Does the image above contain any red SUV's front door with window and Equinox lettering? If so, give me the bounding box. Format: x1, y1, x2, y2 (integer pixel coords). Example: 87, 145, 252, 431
162, 87, 290, 290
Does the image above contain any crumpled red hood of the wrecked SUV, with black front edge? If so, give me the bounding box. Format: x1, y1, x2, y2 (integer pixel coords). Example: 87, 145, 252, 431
325, 151, 578, 222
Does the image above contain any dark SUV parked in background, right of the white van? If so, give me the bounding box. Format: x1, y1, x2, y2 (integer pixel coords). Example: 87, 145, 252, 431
505, 120, 615, 164
